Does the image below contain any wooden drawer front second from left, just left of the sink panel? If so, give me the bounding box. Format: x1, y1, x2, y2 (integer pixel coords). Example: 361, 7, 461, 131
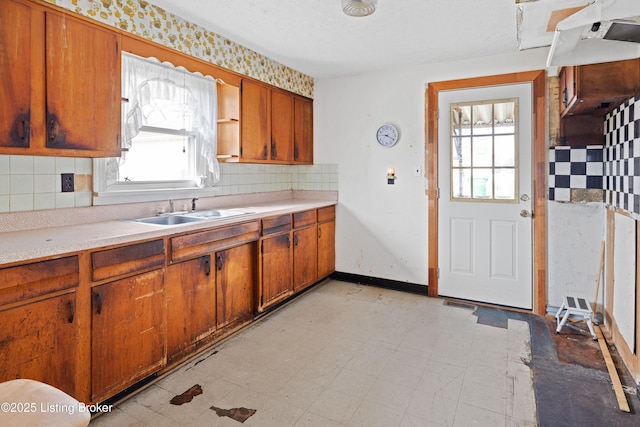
91, 240, 164, 281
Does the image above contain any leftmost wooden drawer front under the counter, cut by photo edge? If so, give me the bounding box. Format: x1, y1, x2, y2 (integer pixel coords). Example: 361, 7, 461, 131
0, 255, 79, 305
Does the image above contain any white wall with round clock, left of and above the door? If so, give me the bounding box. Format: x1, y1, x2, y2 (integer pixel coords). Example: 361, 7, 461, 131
314, 49, 547, 285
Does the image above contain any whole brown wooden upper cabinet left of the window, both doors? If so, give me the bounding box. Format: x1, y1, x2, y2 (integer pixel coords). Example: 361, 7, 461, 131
0, 0, 121, 157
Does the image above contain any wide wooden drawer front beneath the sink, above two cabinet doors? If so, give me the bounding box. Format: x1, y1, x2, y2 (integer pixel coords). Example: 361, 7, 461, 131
171, 221, 260, 262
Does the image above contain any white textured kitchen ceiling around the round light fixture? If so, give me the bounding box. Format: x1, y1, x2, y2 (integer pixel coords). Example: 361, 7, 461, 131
145, 0, 588, 78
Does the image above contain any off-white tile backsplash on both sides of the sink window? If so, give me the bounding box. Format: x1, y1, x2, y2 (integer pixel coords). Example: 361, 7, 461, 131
0, 155, 338, 212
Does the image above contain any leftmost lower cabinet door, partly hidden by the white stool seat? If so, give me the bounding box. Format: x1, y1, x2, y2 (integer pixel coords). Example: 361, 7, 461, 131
0, 291, 78, 397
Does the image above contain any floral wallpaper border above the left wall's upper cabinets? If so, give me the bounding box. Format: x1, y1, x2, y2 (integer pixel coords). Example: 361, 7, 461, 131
41, 0, 313, 98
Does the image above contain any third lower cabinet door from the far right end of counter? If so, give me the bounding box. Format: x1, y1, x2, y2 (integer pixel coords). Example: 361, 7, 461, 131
260, 233, 293, 308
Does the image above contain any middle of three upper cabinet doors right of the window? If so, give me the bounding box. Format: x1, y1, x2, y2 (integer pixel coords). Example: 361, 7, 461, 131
271, 90, 294, 163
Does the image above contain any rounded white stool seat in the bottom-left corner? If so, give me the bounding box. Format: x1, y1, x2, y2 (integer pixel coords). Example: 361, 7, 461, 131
0, 379, 91, 427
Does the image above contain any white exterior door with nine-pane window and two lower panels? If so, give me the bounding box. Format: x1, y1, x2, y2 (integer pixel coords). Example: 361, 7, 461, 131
438, 83, 533, 309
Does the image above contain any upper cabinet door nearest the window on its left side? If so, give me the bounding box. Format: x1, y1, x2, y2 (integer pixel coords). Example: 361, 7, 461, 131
45, 12, 121, 157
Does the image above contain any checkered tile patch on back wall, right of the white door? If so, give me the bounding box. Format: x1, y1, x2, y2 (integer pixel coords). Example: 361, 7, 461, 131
549, 145, 603, 202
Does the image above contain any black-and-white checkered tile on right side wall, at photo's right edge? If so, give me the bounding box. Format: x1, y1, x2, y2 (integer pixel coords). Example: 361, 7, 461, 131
604, 95, 640, 219
